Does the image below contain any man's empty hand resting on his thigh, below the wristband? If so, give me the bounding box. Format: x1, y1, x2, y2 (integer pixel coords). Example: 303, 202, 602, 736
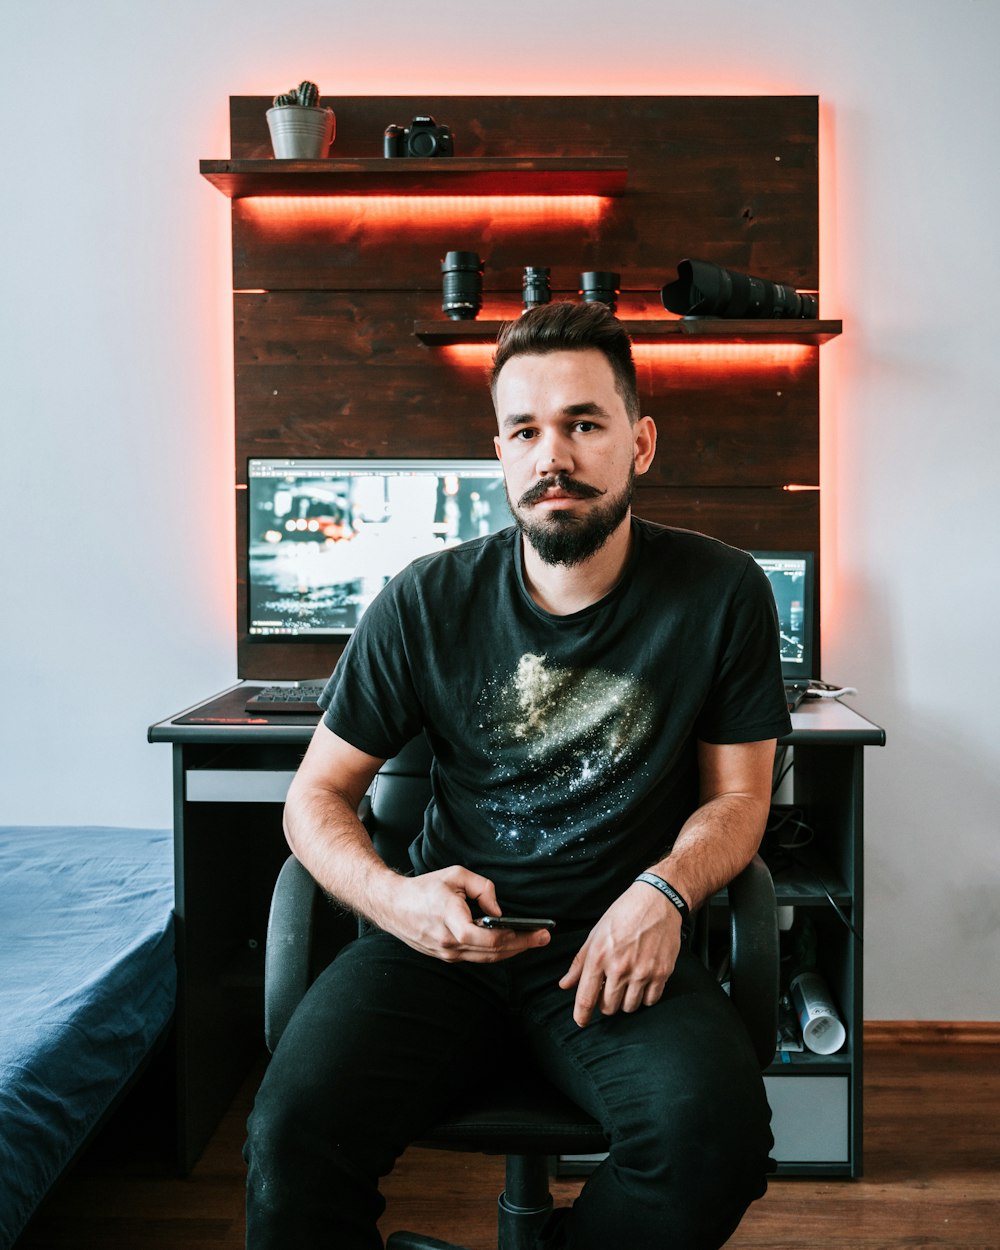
559, 881, 681, 1029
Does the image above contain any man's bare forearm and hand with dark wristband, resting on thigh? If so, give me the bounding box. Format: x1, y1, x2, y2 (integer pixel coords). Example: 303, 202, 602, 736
559, 739, 775, 1028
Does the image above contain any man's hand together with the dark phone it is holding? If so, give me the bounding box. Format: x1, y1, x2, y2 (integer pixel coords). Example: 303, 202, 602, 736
373, 865, 549, 964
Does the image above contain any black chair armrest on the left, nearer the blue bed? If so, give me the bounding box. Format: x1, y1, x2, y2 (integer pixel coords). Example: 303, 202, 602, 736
264, 855, 318, 1051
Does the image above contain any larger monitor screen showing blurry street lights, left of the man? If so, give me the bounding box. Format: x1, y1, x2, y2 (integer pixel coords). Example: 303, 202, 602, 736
246, 459, 513, 641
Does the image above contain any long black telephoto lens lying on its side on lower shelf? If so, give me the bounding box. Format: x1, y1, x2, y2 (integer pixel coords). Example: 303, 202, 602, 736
660, 260, 819, 319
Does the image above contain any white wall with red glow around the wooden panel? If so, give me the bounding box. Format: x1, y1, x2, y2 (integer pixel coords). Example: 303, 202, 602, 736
0, 0, 1000, 1019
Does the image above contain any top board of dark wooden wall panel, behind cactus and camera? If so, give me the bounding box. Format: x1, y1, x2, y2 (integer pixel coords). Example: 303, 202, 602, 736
233, 96, 819, 291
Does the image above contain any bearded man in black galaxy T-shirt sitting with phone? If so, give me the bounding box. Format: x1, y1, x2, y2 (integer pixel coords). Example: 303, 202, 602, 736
248, 304, 790, 1250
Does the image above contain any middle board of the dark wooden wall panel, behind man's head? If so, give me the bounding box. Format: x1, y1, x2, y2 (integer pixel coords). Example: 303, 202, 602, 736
234, 291, 820, 486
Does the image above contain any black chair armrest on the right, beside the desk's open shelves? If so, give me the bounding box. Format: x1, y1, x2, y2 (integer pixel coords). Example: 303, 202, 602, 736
729, 855, 779, 1068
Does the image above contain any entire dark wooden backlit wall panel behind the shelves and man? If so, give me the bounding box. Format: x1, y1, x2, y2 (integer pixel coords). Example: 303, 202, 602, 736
222, 96, 821, 678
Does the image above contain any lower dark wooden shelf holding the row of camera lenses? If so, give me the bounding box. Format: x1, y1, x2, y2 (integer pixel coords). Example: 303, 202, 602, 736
414, 318, 844, 348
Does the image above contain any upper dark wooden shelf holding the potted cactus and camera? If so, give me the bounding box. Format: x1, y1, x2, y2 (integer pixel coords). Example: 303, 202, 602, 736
201, 156, 628, 200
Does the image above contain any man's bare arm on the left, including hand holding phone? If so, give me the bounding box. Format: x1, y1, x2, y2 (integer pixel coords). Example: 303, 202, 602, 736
285, 721, 549, 963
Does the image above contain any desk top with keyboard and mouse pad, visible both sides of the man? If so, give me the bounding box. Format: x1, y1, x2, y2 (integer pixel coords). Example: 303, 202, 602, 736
149, 681, 885, 746
